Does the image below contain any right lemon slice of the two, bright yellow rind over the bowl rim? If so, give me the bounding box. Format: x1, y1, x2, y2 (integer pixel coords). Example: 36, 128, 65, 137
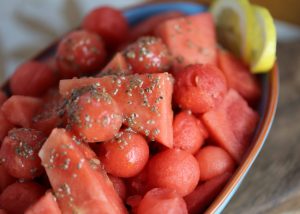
251, 5, 276, 73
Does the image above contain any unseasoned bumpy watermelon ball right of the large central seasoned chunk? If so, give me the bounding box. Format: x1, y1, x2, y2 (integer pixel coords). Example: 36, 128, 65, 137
174, 64, 227, 113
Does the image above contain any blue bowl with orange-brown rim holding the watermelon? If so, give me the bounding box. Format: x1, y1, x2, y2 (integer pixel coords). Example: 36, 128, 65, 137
2, 2, 279, 213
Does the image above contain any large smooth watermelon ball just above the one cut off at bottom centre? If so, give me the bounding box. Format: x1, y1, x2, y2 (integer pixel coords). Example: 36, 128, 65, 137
148, 149, 200, 196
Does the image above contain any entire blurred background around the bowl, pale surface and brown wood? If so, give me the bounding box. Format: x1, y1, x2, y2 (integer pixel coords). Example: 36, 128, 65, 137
0, 0, 300, 214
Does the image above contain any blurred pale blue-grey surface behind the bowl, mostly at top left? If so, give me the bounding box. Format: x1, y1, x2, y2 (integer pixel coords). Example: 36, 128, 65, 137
0, 0, 300, 80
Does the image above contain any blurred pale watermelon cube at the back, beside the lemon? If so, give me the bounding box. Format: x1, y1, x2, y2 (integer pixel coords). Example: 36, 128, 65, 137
156, 13, 217, 72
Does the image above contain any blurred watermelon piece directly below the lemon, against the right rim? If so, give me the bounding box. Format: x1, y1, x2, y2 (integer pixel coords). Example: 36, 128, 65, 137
218, 50, 261, 104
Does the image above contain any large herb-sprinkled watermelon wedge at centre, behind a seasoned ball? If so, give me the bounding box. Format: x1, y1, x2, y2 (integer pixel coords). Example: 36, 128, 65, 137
59, 73, 173, 148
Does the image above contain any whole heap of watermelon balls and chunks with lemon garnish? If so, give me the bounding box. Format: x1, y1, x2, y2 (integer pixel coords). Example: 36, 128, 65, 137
0, 0, 276, 214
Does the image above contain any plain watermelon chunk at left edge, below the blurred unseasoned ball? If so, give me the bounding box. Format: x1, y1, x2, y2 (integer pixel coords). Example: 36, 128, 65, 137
1, 95, 43, 128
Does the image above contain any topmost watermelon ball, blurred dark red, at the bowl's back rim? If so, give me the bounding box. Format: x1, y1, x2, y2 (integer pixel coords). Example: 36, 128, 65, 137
82, 7, 129, 47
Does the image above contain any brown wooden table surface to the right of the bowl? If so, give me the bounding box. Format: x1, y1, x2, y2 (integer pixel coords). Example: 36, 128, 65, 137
224, 40, 300, 214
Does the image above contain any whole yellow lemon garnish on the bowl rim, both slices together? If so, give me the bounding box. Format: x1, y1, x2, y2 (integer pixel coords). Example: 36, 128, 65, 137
211, 0, 276, 73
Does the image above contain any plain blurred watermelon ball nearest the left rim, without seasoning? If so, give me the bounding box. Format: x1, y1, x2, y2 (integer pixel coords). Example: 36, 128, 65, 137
9, 61, 57, 97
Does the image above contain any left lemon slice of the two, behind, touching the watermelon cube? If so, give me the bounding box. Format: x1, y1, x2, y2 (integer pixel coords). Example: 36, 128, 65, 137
211, 0, 255, 61
